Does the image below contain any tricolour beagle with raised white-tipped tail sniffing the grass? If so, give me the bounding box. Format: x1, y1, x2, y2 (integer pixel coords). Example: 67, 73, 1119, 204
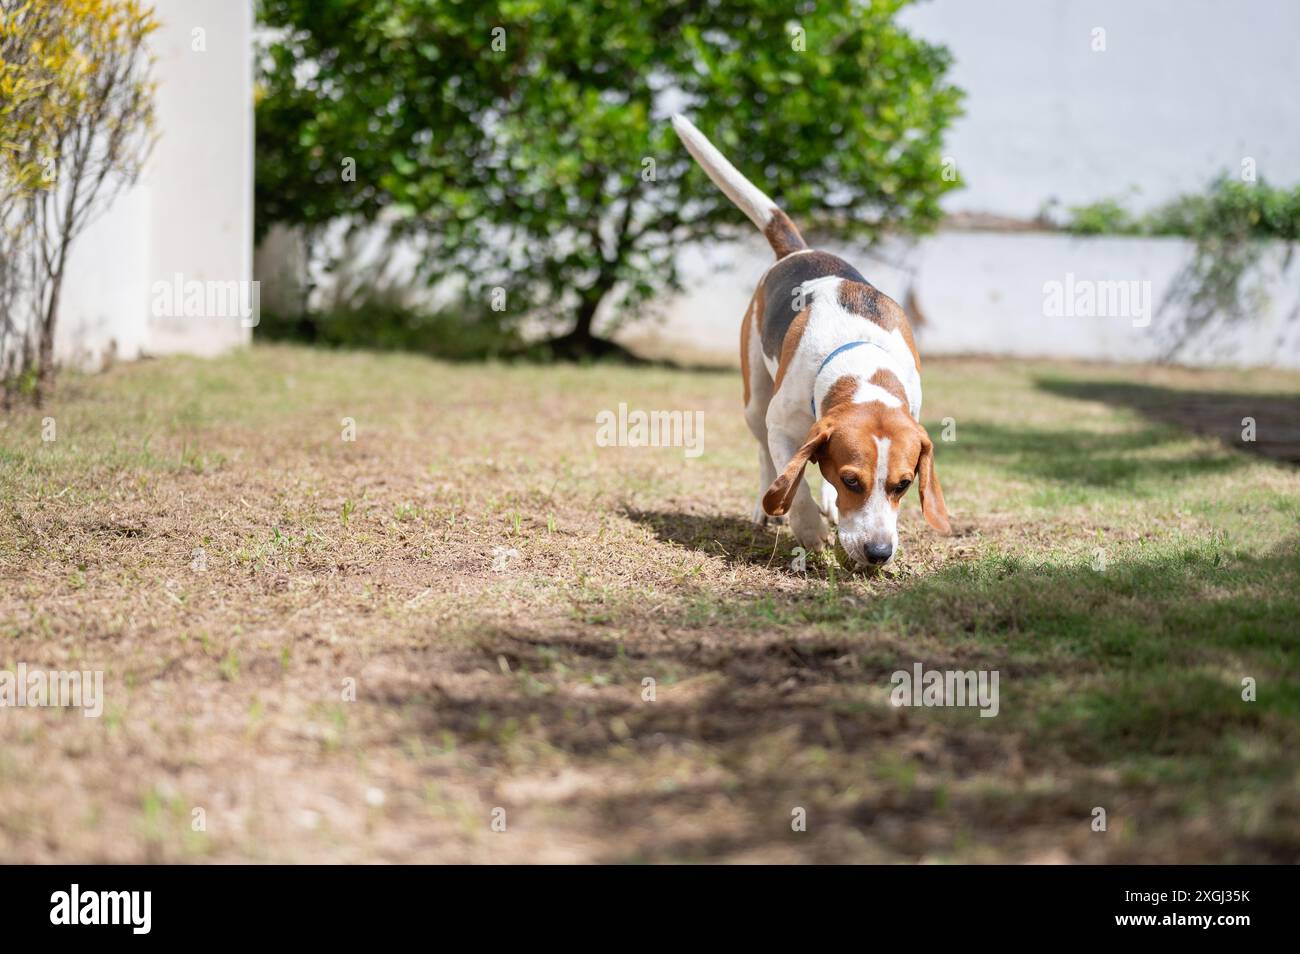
672, 116, 950, 565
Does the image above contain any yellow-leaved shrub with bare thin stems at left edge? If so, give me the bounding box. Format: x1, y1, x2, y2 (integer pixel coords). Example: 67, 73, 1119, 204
0, 0, 157, 395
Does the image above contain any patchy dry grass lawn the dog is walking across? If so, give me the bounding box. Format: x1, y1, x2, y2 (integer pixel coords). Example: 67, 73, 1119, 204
0, 347, 1300, 863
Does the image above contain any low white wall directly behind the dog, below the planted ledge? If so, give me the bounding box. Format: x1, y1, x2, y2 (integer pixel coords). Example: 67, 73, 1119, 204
637, 230, 1300, 368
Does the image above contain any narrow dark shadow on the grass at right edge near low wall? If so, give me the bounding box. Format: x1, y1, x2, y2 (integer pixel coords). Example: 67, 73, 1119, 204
1035, 378, 1300, 464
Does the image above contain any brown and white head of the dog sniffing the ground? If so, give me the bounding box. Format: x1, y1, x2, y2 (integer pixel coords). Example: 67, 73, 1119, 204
763, 402, 952, 565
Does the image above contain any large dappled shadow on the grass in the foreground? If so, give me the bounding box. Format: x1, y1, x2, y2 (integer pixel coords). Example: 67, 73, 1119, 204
395, 538, 1300, 863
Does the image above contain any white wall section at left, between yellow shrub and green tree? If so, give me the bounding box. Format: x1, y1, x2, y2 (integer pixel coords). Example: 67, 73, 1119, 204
56, 0, 254, 368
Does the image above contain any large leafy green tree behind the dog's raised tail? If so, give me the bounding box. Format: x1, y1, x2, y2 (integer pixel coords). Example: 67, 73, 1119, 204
257, 0, 961, 354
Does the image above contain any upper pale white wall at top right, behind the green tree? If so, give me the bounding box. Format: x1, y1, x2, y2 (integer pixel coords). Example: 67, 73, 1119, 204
902, 0, 1300, 217
